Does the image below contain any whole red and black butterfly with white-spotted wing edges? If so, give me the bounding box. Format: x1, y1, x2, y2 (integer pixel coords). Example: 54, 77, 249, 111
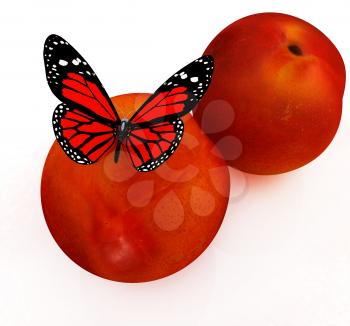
44, 34, 214, 172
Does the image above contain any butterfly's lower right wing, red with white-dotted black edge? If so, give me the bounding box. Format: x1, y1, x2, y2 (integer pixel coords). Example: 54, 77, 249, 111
126, 118, 184, 172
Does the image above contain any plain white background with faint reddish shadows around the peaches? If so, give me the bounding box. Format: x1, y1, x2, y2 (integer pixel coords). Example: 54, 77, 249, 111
0, 0, 350, 326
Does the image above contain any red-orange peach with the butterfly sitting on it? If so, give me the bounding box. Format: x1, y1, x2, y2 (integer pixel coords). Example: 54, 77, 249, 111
41, 94, 229, 282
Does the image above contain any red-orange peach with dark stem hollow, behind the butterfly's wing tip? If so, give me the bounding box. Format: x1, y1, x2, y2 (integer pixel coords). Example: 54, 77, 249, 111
195, 13, 345, 174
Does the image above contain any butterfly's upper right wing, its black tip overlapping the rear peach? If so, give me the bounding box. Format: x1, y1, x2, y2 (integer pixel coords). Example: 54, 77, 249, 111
130, 56, 214, 123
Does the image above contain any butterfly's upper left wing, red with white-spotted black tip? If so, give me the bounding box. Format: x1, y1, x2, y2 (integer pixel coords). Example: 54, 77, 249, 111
44, 35, 120, 123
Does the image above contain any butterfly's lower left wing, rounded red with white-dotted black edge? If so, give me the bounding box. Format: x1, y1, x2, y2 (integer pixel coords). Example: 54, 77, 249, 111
52, 103, 116, 164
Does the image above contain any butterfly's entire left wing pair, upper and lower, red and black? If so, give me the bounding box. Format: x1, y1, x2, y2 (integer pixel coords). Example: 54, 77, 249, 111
44, 35, 120, 164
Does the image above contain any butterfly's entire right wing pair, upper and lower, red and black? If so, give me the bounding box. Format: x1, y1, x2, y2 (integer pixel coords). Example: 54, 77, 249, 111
126, 56, 214, 172
